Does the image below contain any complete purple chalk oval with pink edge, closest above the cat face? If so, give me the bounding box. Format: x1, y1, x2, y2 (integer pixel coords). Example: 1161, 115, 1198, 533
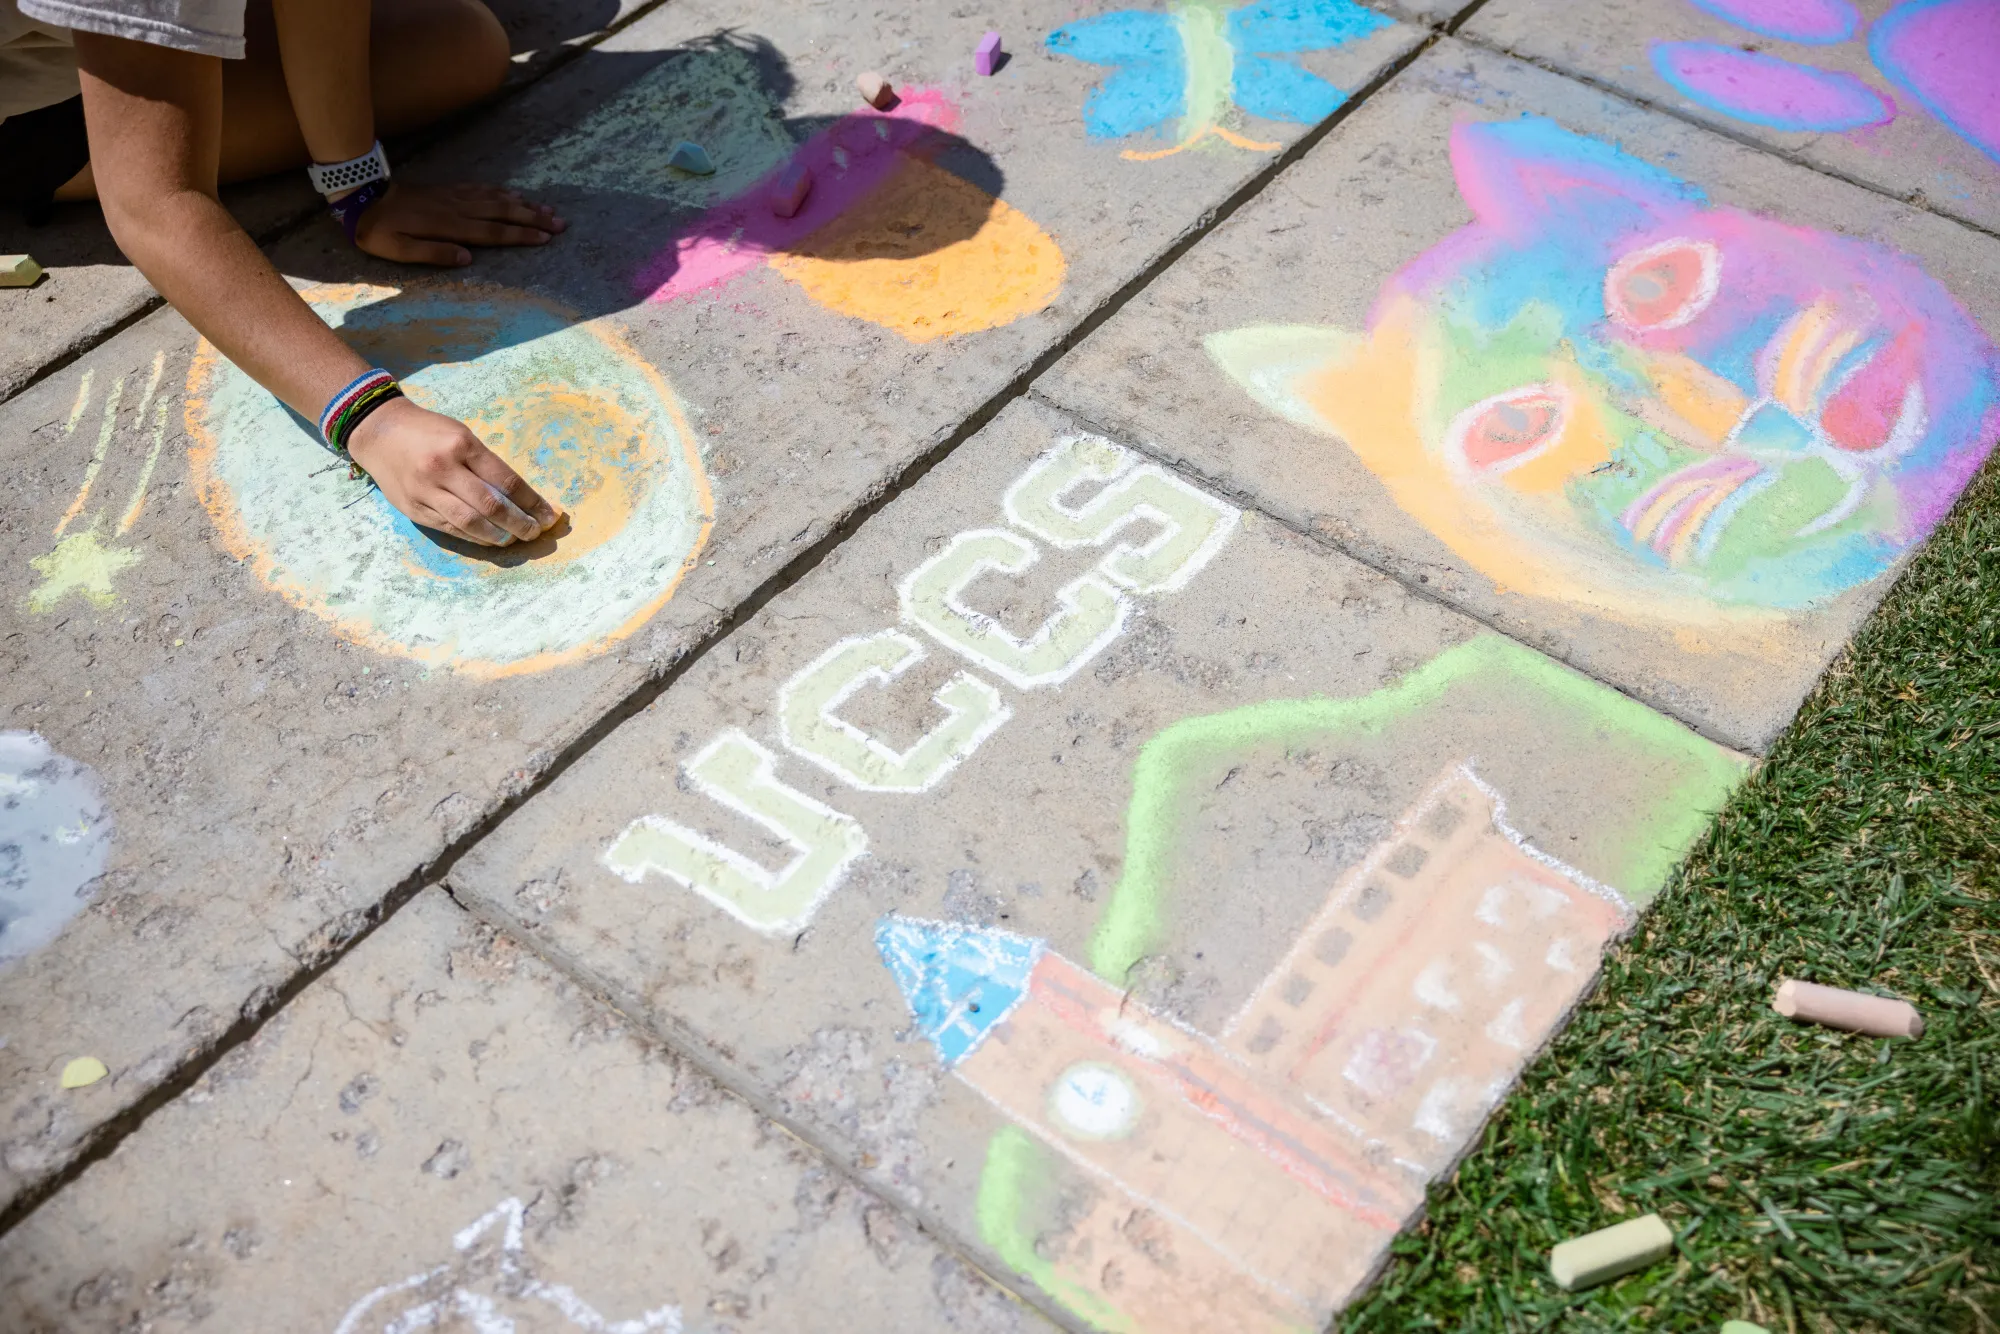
1652, 42, 1896, 130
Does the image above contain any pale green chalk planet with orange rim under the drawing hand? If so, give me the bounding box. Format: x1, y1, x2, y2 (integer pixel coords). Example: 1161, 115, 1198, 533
188, 282, 714, 676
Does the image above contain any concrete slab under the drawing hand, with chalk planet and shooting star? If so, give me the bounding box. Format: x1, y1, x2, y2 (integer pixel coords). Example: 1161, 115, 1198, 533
0, 2, 1418, 1224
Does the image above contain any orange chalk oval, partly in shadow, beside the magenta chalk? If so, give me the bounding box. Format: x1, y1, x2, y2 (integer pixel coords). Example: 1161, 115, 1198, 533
770, 158, 1068, 342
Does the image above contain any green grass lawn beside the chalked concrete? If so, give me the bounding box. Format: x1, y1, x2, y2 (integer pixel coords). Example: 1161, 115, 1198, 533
1338, 464, 2000, 1334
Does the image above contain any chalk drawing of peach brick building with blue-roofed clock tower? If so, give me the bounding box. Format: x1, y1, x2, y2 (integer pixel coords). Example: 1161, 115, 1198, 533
876, 766, 1626, 1330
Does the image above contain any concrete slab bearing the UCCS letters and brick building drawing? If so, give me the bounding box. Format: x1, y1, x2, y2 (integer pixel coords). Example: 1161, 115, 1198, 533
452, 402, 1742, 1330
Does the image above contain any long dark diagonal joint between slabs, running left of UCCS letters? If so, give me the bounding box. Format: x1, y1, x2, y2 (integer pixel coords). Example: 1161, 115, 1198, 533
0, 18, 1444, 1256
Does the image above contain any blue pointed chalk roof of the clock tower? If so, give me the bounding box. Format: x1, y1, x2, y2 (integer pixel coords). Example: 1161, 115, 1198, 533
876, 918, 1044, 1068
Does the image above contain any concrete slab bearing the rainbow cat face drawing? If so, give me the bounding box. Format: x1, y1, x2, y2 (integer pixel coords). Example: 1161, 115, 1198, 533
1038, 40, 2000, 750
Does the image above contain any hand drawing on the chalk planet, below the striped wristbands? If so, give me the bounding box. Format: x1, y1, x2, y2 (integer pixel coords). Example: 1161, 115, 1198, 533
348, 394, 558, 546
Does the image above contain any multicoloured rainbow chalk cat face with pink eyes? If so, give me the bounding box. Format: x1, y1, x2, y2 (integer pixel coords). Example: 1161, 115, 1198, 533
1206, 116, 2000, 624
